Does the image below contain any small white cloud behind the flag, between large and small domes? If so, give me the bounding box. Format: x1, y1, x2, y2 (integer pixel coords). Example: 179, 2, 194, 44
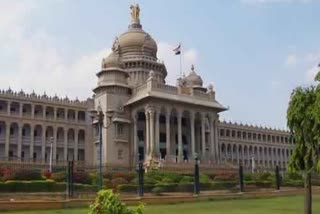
158, 42, 199, 85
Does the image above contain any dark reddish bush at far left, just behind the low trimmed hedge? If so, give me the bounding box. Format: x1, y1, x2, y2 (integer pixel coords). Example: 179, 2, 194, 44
3, 168, 43, 181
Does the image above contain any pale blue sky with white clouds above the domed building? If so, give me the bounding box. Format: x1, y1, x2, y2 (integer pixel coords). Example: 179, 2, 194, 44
0, 0, 320, 129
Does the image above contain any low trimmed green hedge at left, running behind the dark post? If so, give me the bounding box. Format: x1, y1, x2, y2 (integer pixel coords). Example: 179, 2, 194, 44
0, 180, 97, 192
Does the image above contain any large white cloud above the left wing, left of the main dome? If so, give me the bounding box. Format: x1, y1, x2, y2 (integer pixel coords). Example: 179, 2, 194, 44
0, 1, 110, 99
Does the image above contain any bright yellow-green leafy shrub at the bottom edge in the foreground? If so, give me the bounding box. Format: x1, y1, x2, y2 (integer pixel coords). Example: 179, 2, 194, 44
89, 190, 143, 214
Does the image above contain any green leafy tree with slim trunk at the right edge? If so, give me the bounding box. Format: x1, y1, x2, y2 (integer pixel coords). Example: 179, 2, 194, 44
287, 70, 320, 214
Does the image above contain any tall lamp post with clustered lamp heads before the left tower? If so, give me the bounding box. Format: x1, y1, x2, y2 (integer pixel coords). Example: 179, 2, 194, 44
89, 104, 113, 190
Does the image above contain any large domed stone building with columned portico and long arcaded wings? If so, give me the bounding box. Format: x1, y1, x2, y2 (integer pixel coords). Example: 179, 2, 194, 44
0, 5, 293, 170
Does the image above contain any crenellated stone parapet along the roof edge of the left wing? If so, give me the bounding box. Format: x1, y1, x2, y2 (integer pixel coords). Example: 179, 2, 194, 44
0, 88, 91, 107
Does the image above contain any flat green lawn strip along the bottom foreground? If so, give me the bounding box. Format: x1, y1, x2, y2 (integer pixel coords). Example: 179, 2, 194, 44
4, 195, 320, 214
